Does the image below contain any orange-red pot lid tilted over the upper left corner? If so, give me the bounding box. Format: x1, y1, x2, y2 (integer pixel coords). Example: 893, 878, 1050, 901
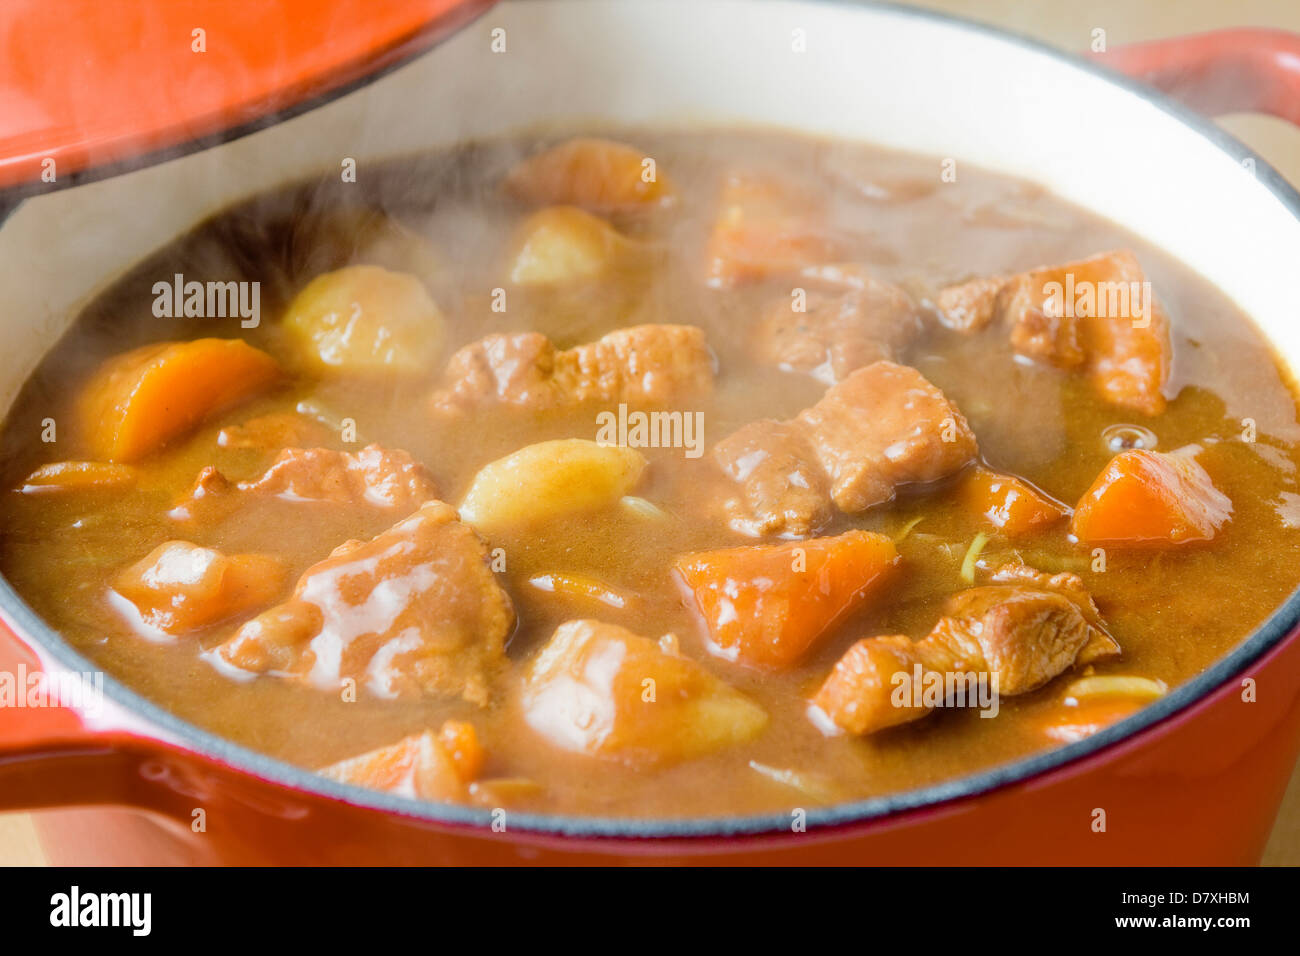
0, 0, 495, 193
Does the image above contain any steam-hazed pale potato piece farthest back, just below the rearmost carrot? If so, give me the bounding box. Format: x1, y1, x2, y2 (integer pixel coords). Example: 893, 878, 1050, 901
510, 206, 634, 285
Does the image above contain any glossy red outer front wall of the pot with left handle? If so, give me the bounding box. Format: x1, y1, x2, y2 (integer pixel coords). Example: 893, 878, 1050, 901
0, 613, 1300, 865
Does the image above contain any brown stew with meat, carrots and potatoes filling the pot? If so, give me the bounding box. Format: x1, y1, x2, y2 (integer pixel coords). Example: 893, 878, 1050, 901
0, 130, 1300, 817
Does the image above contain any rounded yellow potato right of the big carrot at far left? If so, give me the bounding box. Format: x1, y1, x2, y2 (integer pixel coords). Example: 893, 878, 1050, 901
285, 265, 446, 375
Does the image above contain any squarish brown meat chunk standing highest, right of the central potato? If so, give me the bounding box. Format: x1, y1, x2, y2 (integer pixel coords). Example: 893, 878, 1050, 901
797, 362, 979, 514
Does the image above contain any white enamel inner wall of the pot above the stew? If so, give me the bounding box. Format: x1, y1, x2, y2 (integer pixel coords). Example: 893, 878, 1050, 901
0, 0, 1300, 408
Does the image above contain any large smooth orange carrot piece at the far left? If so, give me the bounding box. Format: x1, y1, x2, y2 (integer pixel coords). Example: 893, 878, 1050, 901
81, 338, 280, 462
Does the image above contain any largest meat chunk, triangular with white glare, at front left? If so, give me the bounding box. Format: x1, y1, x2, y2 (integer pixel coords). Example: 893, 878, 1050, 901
215, 501, 515, 704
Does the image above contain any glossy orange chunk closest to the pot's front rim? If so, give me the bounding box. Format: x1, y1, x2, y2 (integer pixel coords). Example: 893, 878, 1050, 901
320, 721, 485, 800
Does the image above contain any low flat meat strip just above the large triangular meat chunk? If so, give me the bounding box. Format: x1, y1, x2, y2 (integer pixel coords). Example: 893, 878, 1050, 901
238, 445, 438, 511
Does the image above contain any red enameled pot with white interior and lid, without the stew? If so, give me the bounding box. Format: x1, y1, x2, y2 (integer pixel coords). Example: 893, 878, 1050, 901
0, 0, 1300, 864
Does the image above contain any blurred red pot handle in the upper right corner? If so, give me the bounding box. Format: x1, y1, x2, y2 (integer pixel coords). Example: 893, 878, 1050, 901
1089, 29, 1300, 126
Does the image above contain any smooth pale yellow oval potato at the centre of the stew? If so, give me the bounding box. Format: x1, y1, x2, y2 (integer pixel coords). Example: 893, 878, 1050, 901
460, 438, 646, 532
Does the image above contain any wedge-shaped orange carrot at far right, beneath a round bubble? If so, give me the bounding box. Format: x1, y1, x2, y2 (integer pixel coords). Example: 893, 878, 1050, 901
1070, 449, 1232, 548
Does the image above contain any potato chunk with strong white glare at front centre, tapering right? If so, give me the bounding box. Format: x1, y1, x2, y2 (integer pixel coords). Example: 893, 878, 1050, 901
524, 620, 767, 767
